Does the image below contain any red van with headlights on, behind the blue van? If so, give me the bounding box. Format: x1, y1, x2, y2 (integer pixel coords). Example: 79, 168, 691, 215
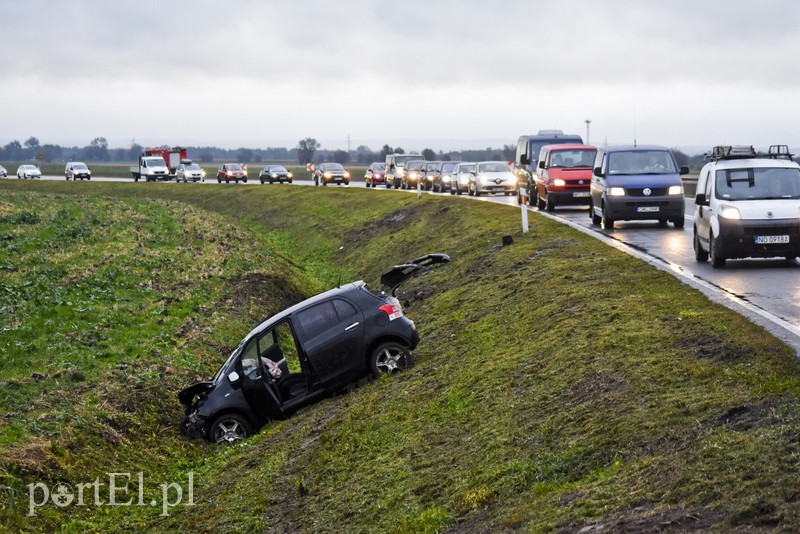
528, 143, 597, 211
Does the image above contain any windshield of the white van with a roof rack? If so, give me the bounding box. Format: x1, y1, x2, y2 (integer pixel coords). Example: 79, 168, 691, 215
716, 167, 800, 200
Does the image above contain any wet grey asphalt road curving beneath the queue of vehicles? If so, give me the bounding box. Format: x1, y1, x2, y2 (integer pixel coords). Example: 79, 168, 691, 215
23, 176, 800, 354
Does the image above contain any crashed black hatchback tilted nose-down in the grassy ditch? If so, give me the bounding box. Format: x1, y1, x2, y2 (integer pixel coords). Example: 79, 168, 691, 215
178, 254, 449, 443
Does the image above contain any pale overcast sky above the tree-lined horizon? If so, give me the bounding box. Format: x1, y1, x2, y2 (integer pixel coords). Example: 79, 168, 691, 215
0, 0, 800, 150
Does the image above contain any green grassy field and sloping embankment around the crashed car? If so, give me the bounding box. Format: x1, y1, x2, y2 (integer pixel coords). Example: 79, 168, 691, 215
0, 182, 800, 532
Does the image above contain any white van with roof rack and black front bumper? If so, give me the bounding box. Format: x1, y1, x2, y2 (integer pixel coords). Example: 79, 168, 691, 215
693, 145, 800, 268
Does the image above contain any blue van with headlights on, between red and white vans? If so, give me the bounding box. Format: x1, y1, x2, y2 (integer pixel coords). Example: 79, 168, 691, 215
589, 145, 689, 230
